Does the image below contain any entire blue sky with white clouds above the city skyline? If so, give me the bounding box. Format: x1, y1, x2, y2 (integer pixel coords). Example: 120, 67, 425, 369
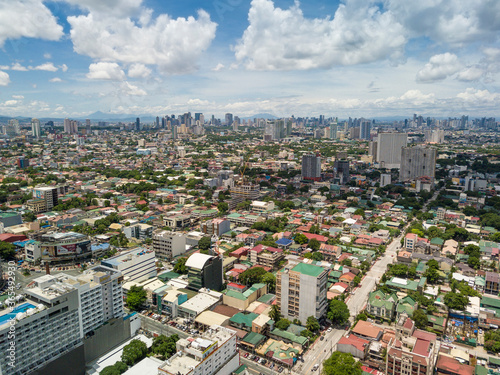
0, 0, 500, 118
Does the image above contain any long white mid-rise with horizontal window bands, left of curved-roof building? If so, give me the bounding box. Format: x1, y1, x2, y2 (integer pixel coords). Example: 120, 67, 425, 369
101, 247, 156, 282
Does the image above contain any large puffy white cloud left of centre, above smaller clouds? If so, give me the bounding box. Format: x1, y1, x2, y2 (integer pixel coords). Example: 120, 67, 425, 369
68, 8, 217, 74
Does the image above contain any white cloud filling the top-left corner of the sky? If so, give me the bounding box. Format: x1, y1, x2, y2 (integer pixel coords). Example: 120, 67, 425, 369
0, 0, 63, 47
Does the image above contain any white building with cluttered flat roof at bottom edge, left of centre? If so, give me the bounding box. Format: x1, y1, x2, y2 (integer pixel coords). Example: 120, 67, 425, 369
158, 325, 240, 375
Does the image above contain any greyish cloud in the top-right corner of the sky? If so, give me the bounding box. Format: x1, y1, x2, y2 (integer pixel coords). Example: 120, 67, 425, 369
384, 0, 500, 45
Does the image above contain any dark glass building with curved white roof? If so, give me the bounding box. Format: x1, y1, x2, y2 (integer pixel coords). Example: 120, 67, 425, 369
186, 253, 223, 291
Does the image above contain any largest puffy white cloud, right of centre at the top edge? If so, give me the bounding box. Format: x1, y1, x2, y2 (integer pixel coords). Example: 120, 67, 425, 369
234, 0, 406, 70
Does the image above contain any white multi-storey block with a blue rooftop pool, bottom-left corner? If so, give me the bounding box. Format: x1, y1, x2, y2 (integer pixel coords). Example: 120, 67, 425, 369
0, 275, 85, 375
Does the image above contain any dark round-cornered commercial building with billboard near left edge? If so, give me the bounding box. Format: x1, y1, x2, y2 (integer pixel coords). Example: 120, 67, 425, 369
39, 232, 92, 263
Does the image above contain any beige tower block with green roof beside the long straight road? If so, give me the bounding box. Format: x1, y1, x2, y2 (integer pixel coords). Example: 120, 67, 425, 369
276, 263, 328, 322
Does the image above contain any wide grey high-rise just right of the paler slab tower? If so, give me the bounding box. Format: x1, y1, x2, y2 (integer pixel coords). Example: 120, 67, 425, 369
399, 146, 437, 181
